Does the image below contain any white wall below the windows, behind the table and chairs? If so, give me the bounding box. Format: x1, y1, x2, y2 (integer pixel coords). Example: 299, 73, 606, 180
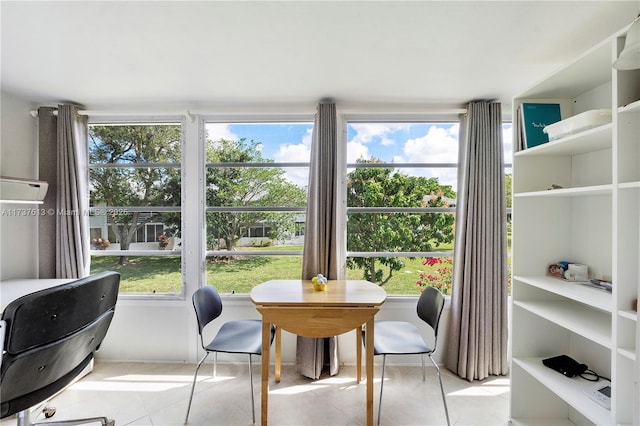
97, 295, 449, 365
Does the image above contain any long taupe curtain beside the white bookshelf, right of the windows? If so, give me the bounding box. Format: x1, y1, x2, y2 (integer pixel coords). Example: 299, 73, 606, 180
446, 101, 508, 381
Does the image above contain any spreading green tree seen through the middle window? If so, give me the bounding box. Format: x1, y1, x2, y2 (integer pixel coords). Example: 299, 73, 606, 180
206, 139, 307, 251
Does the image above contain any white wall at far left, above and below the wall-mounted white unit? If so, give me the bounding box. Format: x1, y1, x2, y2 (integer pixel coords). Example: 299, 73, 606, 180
0, 92, 38, 280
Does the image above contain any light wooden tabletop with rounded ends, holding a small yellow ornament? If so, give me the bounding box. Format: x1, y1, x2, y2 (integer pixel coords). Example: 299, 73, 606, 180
251, 280, 387, 307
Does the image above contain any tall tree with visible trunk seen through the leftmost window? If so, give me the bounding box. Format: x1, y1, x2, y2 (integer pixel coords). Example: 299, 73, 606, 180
89, 125, 181, 265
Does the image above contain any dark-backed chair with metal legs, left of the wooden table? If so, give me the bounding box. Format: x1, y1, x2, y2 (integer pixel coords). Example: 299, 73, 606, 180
184, 285, 275, 424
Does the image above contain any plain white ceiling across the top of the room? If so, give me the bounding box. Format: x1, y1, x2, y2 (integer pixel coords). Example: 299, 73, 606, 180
0, 0, 640, 109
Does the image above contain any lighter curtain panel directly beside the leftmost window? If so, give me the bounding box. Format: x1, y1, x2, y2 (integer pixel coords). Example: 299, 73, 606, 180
56, 105, 90, 278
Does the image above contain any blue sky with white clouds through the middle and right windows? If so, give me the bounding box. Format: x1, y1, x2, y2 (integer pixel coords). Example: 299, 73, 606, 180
206, 123, 512, 189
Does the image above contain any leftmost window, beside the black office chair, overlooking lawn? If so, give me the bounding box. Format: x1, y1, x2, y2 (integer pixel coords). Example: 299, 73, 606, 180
89, 123, 183, 295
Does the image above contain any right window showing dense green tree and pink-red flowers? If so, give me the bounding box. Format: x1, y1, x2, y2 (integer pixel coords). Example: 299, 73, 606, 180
345, 120, 511, 294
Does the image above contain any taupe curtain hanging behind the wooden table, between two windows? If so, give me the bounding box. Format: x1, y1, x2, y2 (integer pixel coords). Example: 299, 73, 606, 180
296, 103, 343, 379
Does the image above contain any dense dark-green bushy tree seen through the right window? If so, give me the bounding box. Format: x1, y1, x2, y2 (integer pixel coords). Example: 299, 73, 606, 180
347, 159, 455, 285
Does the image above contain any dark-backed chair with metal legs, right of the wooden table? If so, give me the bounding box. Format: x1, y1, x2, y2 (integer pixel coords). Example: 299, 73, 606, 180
373, 287, 451, 425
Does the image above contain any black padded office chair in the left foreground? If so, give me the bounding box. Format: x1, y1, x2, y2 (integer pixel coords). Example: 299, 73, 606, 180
0, 272, 120, 426
